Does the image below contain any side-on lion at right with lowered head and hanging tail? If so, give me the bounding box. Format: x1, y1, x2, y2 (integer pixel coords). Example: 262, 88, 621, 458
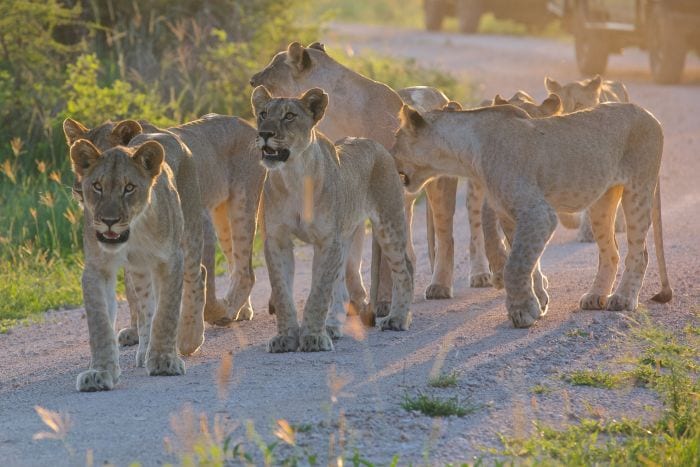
392, 103, 673, 327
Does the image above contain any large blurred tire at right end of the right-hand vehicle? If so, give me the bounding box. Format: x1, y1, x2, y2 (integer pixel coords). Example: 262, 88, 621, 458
647, 3, 688, 84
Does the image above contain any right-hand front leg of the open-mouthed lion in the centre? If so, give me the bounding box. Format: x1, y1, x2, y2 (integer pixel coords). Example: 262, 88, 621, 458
299, 238, 345, 352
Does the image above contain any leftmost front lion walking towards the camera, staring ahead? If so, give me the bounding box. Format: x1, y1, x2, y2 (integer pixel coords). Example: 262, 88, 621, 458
70, 139, 193, 391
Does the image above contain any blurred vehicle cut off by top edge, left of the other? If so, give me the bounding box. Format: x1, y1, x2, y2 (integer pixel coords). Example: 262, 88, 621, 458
423, 0, 551, 34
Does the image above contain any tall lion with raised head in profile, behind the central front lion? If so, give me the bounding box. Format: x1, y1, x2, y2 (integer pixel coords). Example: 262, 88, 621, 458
250, 42, 470, 310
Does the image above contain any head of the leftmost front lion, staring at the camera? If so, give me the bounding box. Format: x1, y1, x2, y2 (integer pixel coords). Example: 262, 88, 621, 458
70, 139, 165, 250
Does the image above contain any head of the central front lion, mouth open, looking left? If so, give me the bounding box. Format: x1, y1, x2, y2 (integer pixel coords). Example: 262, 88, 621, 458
251, 86, 328, 169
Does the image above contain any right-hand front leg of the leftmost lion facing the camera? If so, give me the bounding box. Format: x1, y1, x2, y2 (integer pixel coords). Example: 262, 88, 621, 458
146, 251, 185, 376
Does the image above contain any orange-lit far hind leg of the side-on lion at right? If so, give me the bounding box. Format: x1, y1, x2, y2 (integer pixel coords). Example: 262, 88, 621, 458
580, 186, 622, 310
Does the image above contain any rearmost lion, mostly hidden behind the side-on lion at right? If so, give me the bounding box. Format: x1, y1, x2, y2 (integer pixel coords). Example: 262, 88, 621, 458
544, 76, 629, 243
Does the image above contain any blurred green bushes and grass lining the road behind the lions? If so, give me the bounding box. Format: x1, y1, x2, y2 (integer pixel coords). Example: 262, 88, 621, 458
0, 0, 463, 331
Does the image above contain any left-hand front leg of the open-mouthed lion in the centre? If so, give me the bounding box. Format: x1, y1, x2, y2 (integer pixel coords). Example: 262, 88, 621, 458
265, 236, 299, 353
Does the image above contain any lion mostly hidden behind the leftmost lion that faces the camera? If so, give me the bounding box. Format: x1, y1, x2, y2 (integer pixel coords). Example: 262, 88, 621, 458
63, 114, 265, 332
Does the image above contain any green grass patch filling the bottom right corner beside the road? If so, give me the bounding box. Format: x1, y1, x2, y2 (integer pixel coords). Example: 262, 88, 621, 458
498, 319, 700, 465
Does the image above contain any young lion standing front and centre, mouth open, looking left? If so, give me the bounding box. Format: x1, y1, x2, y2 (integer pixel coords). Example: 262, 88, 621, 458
251, 86, 413, 352
